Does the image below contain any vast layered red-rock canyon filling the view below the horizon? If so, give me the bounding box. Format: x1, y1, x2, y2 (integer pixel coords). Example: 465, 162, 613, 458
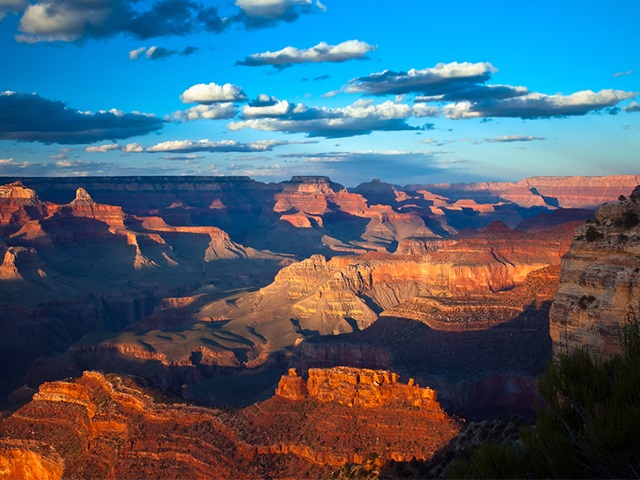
0, 175, 640, 478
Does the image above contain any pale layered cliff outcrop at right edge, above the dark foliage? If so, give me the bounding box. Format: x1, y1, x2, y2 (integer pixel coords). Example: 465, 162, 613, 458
550, 188, 640, 356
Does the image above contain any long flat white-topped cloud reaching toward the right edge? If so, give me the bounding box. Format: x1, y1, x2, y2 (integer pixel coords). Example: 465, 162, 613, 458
443, 90, 637, 119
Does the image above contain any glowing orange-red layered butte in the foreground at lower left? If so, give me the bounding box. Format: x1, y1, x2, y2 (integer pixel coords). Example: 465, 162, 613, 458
0, 368, 460, 479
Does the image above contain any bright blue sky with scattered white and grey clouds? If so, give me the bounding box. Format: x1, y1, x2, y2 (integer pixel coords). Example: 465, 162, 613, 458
0, 0, 640, 186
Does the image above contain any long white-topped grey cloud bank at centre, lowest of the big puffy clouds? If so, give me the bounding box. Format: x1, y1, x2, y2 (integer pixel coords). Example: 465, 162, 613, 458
228, 95, 440, 138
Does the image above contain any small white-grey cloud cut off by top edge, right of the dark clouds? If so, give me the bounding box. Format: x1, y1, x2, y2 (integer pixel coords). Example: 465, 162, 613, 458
232, 0, 326, 28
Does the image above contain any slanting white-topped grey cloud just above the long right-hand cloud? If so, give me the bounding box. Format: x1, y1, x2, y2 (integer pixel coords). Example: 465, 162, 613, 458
343, 62, 497, 95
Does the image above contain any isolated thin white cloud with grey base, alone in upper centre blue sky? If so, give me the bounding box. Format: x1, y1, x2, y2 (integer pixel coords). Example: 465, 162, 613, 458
236, 40, 376, 68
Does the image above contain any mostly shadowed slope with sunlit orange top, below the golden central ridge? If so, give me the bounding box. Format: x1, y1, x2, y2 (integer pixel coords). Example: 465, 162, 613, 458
290, 266, 559, 416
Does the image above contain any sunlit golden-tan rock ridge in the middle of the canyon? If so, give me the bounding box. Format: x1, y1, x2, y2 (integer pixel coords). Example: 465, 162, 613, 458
201, 222, 573, 341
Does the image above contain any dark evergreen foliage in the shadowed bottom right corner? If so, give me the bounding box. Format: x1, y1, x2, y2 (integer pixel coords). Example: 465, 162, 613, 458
447, 321, 640, 478
